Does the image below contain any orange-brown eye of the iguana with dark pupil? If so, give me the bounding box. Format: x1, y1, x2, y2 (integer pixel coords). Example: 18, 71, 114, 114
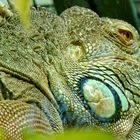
118, 29, 133, 45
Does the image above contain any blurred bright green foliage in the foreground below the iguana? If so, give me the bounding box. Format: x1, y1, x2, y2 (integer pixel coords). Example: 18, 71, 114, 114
24, 129, 117, 140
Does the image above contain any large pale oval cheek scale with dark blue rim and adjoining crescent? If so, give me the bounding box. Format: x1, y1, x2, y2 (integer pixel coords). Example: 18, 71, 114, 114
81, 78, 129, 123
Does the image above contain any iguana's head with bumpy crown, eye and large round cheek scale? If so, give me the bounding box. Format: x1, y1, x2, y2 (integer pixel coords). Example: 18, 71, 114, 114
47, 7, 140, 140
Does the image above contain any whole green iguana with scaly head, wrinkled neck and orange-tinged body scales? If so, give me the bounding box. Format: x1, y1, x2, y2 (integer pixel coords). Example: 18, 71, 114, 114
0, 3, 140, 140
